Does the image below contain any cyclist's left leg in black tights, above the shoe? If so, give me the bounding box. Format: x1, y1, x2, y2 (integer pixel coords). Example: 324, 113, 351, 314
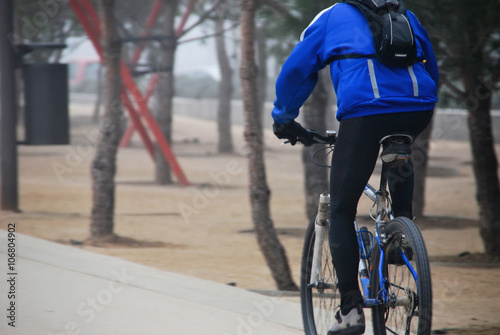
329, 117, 380, 315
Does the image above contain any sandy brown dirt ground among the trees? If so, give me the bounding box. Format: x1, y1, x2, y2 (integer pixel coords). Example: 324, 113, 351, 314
0, 107, 500, 335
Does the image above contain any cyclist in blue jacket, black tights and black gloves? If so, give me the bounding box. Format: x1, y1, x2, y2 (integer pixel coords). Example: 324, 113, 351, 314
272, 3, 439, 335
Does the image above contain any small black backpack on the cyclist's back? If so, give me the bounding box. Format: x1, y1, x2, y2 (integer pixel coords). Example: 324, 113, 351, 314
335, 0, 417, 66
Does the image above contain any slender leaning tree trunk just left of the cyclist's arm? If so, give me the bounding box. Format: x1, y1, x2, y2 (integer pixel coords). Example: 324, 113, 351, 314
240, 0, 298, 290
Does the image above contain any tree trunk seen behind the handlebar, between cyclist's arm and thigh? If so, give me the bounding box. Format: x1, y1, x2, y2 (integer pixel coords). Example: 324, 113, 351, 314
302, 70, 330, 218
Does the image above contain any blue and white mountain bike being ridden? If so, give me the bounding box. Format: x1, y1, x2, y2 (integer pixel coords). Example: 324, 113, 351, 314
292, 131, 432, 335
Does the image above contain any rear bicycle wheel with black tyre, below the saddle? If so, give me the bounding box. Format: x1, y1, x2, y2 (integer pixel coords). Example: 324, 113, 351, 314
370, 217, 432, 335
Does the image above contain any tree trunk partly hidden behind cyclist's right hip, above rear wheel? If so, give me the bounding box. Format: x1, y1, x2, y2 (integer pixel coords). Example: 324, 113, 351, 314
411, 122, 432, 218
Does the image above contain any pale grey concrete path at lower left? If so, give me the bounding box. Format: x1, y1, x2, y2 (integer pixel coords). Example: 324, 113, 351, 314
0, 234, 303, 335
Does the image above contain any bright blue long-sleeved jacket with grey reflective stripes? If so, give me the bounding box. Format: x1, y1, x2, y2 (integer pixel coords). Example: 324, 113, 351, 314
272, 3, 439, 124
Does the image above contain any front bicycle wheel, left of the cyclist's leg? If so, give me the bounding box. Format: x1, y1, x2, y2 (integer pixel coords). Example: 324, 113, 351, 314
300, 214, 340, 335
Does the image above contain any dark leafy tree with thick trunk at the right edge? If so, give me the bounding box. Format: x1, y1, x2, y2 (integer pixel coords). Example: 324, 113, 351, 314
414, 0, 500, 260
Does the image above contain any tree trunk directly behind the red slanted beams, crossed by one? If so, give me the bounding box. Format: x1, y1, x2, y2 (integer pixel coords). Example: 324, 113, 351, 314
154, 0, 178, 185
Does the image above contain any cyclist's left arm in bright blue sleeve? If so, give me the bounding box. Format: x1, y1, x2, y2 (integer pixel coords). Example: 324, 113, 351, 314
272, 9, 329, 124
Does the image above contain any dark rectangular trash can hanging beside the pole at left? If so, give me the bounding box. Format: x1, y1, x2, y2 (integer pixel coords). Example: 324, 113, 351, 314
23, 64, 70, 145
